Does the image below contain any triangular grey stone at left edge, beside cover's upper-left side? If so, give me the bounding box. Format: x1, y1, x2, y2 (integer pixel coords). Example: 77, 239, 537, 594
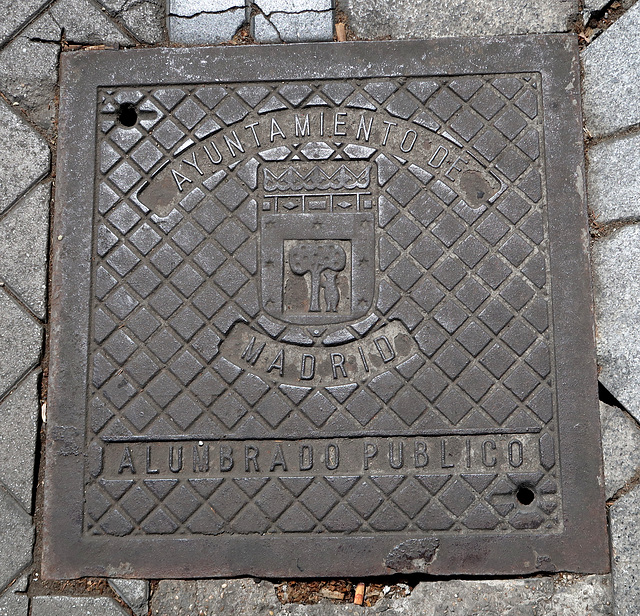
0, 100, 50, 214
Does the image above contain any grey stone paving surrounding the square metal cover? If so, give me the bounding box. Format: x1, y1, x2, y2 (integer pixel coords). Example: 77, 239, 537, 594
0, 0, 640, 616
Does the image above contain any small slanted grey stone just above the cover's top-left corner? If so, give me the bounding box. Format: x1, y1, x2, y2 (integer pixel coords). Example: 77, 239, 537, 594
49, 0, 133, 45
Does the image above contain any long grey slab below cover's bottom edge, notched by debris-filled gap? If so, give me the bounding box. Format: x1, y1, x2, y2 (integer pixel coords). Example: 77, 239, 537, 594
151, 575, 613, 616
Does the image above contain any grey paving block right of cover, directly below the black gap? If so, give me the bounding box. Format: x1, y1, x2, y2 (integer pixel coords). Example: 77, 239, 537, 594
600, 402, 640, 499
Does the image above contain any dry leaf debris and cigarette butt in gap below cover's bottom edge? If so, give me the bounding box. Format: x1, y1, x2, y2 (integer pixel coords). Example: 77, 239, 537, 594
276, 580, 412, 607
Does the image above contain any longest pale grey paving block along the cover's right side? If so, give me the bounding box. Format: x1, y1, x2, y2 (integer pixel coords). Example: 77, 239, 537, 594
592, 225, 640, 420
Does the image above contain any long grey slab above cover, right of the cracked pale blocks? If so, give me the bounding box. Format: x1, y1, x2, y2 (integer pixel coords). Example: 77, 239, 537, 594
340, 0, 578, 39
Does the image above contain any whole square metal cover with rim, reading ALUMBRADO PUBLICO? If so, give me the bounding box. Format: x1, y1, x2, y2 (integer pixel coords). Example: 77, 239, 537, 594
44, 36, 608, 578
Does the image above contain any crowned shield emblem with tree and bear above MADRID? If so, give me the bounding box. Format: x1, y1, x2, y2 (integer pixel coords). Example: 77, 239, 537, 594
260, 163, 376, 325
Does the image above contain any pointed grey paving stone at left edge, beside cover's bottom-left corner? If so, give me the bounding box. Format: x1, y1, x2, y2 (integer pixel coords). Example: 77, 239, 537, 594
0, 487, 34, 591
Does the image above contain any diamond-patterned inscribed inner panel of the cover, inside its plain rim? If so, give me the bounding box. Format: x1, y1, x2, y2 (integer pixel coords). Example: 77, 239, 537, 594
46, 39, 608, 575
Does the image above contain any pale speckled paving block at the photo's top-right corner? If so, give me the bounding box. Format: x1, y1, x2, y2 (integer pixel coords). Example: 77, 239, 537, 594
582, 3, 640, 137
